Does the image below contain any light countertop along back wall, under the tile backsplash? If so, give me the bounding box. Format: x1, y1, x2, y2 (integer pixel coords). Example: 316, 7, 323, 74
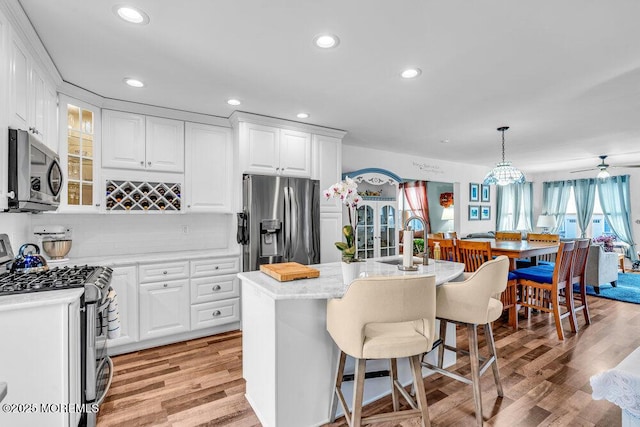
52, 249, 240, 267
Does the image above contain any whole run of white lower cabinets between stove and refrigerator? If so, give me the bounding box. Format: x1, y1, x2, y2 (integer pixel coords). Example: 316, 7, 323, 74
107, 256, 240, 355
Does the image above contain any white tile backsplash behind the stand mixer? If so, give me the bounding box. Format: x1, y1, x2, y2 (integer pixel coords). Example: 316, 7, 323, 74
0, 213, 236, 258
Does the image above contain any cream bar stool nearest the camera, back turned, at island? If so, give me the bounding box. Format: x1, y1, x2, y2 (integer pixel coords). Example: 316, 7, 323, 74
327, 276, 436, 427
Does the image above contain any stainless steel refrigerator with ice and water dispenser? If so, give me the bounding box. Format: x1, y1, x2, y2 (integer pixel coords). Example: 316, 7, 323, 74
237, 175, 320, 271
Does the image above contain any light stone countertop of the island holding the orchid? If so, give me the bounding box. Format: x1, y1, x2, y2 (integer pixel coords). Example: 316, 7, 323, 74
238, 257, 464, 300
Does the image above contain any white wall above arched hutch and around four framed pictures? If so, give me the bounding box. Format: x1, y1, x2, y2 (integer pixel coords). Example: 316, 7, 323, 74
342, 144, 496, 236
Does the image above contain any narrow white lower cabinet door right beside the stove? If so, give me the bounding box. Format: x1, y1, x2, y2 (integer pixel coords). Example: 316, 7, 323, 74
107, 265, 138, 348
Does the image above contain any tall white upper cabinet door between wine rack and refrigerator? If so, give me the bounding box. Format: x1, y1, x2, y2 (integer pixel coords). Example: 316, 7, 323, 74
185, 123, 234, 213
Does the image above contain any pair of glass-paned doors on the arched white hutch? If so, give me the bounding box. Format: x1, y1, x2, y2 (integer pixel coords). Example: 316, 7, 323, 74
356, 201, 397, 259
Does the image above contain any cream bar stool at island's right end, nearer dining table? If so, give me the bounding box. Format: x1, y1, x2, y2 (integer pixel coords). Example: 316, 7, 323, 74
422, 255, 509, 426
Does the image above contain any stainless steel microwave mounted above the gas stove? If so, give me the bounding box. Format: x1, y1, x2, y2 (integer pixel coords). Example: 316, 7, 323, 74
8, 129, 62, 212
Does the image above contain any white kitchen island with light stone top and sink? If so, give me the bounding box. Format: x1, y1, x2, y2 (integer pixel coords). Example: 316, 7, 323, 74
238, 258, 464, 427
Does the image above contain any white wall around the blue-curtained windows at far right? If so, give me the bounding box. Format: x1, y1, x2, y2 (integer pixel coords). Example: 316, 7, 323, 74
527, 168, 640, 250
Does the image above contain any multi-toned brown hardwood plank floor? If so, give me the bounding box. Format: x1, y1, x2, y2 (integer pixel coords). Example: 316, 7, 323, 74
98, 297, 640, 427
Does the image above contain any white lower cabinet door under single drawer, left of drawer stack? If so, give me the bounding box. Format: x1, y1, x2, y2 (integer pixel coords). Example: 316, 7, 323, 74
139, 279, 190, 340
